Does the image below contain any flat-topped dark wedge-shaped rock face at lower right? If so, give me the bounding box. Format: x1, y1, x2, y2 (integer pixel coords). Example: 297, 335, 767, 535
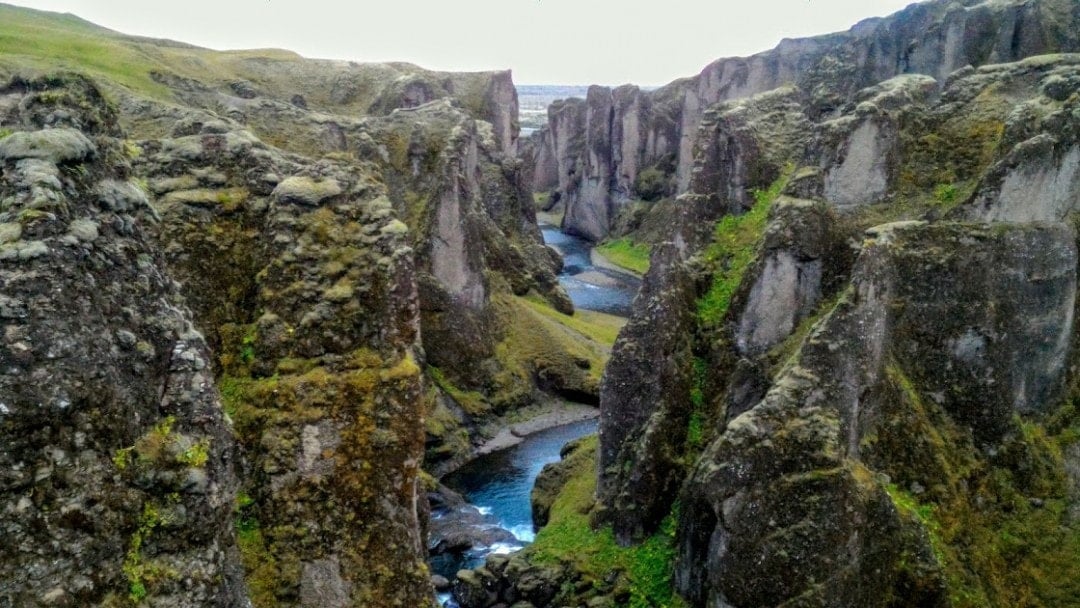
676, 222, 1076, 606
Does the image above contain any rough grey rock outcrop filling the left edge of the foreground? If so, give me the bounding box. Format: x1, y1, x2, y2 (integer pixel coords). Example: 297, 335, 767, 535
0, 76, 247, 608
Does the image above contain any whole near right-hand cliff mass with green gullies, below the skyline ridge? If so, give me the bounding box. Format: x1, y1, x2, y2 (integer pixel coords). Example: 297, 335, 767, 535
458, 35, 1080, 607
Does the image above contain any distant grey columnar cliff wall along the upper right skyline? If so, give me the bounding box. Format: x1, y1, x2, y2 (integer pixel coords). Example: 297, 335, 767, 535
527, 0, 1080, 245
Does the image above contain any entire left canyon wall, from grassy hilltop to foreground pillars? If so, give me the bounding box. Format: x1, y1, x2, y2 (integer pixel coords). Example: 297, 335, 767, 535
0, 6, 606, 607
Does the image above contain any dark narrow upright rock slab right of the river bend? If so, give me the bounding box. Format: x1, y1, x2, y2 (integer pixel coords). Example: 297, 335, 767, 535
597, 244, 697, 542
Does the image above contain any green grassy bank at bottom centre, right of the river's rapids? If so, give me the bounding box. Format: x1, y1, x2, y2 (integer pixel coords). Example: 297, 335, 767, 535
526, 435, 685, 608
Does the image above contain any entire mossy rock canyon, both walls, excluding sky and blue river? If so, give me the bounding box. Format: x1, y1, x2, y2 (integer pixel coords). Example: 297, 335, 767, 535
0, 0, 1080, 608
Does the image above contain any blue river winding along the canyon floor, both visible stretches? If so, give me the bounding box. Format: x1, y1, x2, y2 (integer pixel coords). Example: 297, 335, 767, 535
429, 224, 640, 608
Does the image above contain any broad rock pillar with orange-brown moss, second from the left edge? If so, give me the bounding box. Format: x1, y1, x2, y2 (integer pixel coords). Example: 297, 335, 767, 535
124, 89, 431, 606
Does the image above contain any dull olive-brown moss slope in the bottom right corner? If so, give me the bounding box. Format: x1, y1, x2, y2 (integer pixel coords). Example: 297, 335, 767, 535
863, 363, 1080, 608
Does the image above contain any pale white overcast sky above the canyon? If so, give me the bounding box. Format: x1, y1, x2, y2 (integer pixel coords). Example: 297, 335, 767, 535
11, 0, 913, 85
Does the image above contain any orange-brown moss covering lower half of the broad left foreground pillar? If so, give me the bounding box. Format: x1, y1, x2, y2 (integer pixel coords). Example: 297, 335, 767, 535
219, 352, 427, 608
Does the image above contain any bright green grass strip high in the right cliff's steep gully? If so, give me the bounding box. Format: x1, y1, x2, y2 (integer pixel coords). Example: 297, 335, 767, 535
698, 170, 792, 327
